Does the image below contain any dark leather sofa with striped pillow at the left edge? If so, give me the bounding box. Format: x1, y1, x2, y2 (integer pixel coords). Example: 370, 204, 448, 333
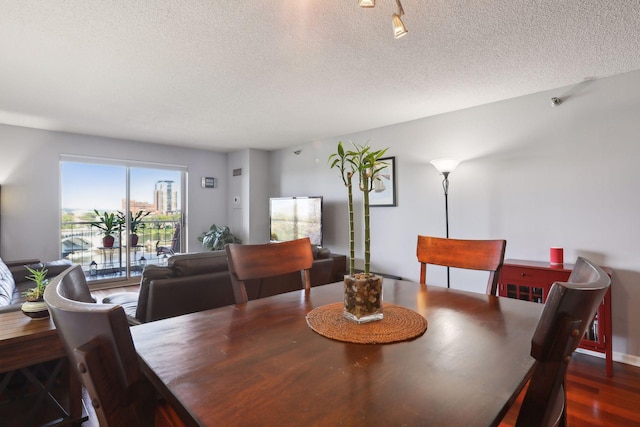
0, 259, 71, 313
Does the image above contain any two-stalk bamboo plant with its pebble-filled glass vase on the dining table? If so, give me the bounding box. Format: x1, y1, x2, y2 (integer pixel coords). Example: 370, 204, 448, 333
329, 142, 388, 323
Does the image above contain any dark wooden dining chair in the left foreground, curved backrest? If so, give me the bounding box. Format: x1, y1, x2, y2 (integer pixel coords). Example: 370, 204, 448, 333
44, 265, 182, 426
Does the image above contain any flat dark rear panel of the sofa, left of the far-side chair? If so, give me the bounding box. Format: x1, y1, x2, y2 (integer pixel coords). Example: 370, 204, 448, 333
140, 271, 235, 322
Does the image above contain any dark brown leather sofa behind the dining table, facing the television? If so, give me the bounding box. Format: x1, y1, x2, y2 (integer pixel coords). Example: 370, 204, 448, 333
103, 249, 346, 324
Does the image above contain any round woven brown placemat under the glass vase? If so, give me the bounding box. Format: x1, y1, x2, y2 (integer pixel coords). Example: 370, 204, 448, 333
307, 302, 427, 344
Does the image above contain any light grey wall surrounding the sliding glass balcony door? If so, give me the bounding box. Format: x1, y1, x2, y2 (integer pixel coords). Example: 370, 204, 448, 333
0, 125, 228, 260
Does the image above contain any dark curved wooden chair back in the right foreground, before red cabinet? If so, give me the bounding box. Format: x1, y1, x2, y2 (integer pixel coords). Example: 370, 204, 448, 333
516, 257, 611, 427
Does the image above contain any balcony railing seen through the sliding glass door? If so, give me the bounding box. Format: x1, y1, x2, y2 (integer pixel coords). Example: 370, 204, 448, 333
60, 220, 181, 280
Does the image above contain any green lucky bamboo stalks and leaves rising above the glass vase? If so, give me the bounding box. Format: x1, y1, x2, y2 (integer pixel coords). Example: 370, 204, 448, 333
329, 141, 388, 276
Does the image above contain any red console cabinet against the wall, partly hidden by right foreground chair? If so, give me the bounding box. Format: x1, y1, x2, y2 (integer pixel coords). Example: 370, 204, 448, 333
498, 259, 613, 376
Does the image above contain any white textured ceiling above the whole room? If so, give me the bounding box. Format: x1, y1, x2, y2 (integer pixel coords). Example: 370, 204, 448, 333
0, 0, 640, 151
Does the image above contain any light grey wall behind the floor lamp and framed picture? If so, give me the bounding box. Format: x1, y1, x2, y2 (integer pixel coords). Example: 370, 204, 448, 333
270, 72, 640, 364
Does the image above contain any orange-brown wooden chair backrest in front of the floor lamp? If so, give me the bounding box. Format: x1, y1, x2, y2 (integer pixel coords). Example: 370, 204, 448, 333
416, 236, 507, 295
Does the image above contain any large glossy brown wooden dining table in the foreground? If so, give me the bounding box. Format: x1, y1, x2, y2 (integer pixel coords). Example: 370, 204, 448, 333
131, 278, 543, 426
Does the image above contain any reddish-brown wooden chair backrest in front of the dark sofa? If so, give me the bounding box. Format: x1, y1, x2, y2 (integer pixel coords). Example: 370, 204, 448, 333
225, 237, 313, 304
